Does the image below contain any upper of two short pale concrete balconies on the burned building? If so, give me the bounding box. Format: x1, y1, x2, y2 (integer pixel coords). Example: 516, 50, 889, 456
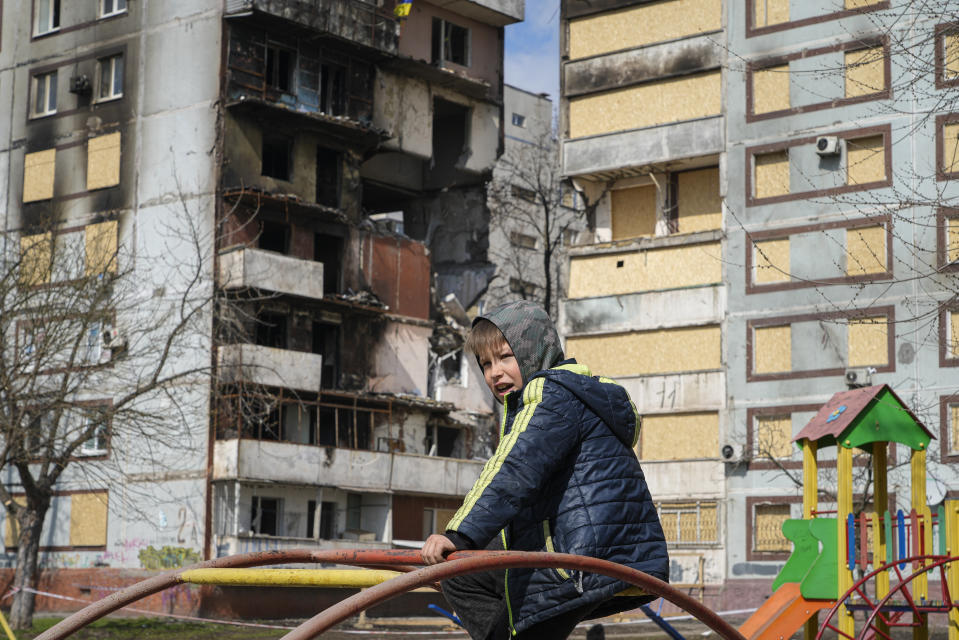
218, 247, 323, 299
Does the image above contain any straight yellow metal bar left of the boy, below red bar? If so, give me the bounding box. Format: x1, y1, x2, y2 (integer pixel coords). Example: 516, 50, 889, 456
180, 569, 402, 589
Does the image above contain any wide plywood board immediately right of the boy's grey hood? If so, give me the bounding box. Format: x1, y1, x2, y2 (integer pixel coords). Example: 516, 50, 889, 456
566, 326, 722, 378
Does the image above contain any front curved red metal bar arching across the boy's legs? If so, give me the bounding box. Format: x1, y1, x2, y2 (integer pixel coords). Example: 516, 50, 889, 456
282, 551, 745, 640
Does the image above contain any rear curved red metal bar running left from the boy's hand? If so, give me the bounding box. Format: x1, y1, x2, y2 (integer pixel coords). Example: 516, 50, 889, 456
36, 549, 444, 640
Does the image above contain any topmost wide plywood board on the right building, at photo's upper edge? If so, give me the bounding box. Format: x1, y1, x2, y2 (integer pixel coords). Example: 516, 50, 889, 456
569, 0, 723, 60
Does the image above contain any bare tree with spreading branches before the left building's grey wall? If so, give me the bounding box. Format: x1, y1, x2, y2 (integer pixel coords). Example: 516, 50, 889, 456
0, 205, 214, 629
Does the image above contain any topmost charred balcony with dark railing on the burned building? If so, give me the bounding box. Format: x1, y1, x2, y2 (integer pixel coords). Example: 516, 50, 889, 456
226, 0, 398, 54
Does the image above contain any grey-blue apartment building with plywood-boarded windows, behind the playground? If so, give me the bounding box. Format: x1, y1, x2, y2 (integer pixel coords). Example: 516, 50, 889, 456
560, 0, 959, 610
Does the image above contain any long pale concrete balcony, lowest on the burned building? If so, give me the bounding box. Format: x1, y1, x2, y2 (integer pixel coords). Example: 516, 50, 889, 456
213, 439, 483, 496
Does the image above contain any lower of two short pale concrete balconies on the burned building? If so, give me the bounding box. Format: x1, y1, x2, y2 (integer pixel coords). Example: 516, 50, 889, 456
217, 344, 323, 391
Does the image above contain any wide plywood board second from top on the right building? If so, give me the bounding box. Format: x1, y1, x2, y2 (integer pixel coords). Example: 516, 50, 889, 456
569, 71, 722, 138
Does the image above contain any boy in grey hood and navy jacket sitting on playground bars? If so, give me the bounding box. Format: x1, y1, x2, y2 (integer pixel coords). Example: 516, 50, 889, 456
422, 301, 669, 640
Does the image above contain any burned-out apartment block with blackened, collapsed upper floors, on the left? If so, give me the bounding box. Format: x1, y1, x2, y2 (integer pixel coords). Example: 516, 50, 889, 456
0, 0, 523, 608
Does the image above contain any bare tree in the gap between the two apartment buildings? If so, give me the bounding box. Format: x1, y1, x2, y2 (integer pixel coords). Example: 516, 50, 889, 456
487, 128, 595, 314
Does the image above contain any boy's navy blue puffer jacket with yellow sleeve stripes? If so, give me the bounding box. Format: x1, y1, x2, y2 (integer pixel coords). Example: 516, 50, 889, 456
447, 362, 669, 632
